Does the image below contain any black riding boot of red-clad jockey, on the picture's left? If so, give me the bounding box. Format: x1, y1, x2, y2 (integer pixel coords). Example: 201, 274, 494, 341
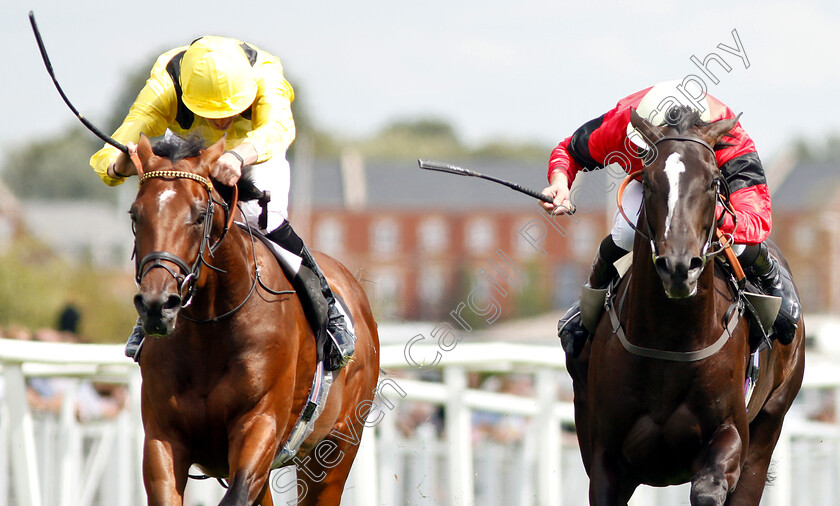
557, 235, 627, 357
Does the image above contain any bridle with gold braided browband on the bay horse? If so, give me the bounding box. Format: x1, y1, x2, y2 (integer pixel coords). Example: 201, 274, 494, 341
132, 170, 238, 308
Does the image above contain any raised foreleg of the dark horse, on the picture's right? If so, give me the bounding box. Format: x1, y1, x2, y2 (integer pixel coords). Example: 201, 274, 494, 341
691, 424, 744, 506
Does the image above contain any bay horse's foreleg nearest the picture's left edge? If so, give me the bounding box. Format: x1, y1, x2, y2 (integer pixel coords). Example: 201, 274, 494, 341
143, 434, 190, 506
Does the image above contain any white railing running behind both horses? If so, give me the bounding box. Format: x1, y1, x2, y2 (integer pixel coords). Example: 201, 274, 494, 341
0, 339, 840, 506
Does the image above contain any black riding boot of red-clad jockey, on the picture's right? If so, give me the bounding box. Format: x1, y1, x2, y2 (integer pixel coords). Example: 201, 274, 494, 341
738, 242, 802, 344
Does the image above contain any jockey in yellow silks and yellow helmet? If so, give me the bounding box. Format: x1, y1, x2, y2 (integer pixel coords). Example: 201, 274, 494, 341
90, 35, 355, 370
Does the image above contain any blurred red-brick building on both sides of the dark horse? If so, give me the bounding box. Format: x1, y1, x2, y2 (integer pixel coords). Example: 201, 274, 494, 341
291, 152, 840, 323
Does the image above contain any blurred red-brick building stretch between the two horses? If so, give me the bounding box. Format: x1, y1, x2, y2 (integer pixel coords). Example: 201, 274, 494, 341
291, 156, 611, 325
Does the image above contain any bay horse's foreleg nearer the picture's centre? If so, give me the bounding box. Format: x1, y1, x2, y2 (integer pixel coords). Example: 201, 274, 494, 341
219, 415, 277, 506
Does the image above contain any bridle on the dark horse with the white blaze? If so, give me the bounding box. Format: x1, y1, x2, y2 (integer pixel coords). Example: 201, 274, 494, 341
616, 136, 737, 266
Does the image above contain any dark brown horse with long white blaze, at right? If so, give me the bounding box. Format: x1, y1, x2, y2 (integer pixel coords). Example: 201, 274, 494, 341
567, 111, 804, 506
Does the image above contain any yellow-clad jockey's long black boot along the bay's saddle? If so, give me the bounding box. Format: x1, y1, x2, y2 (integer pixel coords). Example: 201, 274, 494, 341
267, 221, 356, 371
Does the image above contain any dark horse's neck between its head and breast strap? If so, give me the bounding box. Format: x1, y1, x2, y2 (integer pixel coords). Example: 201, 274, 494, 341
627, 241, 716, 344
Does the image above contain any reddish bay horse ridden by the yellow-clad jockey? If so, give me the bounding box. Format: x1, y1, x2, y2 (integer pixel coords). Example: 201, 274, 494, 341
130, 132, 379, 505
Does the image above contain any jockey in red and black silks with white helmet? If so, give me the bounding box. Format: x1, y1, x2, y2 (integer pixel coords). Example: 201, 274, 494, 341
542, 81, 802, 356
